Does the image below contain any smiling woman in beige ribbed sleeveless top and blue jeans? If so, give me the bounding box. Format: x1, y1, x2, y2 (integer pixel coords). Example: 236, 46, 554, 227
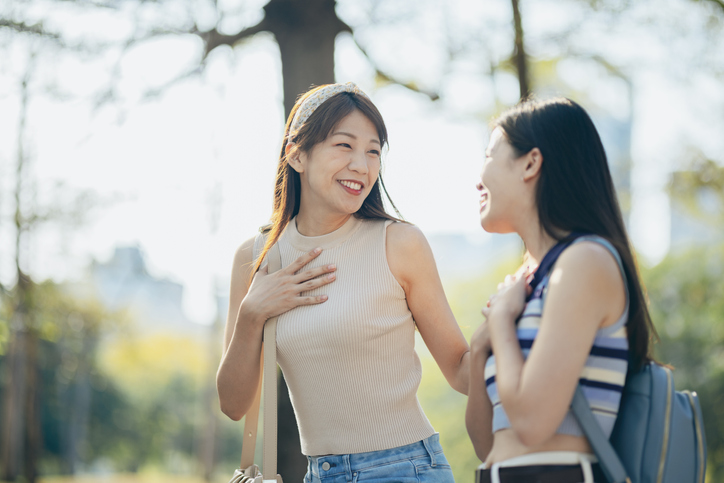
217, 83, 469, 482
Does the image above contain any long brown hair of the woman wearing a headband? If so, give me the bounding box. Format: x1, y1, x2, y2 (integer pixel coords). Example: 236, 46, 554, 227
252, 86, 402, 273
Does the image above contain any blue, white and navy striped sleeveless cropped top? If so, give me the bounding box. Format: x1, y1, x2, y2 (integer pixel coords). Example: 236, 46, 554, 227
485, 235, 629, 437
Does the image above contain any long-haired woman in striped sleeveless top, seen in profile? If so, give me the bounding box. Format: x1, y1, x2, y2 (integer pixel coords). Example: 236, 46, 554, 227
466, 99, 654, 483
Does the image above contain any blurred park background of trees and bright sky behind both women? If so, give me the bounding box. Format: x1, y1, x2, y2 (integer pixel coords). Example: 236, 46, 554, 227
0, 0, 724, 483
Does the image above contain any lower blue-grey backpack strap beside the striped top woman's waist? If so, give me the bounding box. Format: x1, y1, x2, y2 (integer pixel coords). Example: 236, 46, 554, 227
571, 384, 631, 483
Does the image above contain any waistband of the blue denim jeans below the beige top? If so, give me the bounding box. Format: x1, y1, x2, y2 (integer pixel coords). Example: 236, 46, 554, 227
307, 433, 443, 477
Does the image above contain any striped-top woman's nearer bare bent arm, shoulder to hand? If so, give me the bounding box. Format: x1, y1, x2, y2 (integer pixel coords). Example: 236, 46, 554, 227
488, 242, 625, 446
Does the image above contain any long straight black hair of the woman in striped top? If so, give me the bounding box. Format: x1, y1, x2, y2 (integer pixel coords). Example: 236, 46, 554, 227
493, 98, 656, 370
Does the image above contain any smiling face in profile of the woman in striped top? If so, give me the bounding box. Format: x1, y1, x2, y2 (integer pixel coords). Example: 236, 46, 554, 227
477, 128, 526, 233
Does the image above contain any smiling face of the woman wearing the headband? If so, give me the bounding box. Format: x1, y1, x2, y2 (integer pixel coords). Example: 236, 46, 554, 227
290, 109, 382, 216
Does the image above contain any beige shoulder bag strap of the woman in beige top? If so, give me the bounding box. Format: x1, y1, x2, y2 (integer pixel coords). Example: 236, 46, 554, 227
241, 243, 282, 481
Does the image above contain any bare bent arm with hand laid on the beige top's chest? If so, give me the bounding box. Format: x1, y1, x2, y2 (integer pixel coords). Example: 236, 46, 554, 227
216, 238, 336, 421
